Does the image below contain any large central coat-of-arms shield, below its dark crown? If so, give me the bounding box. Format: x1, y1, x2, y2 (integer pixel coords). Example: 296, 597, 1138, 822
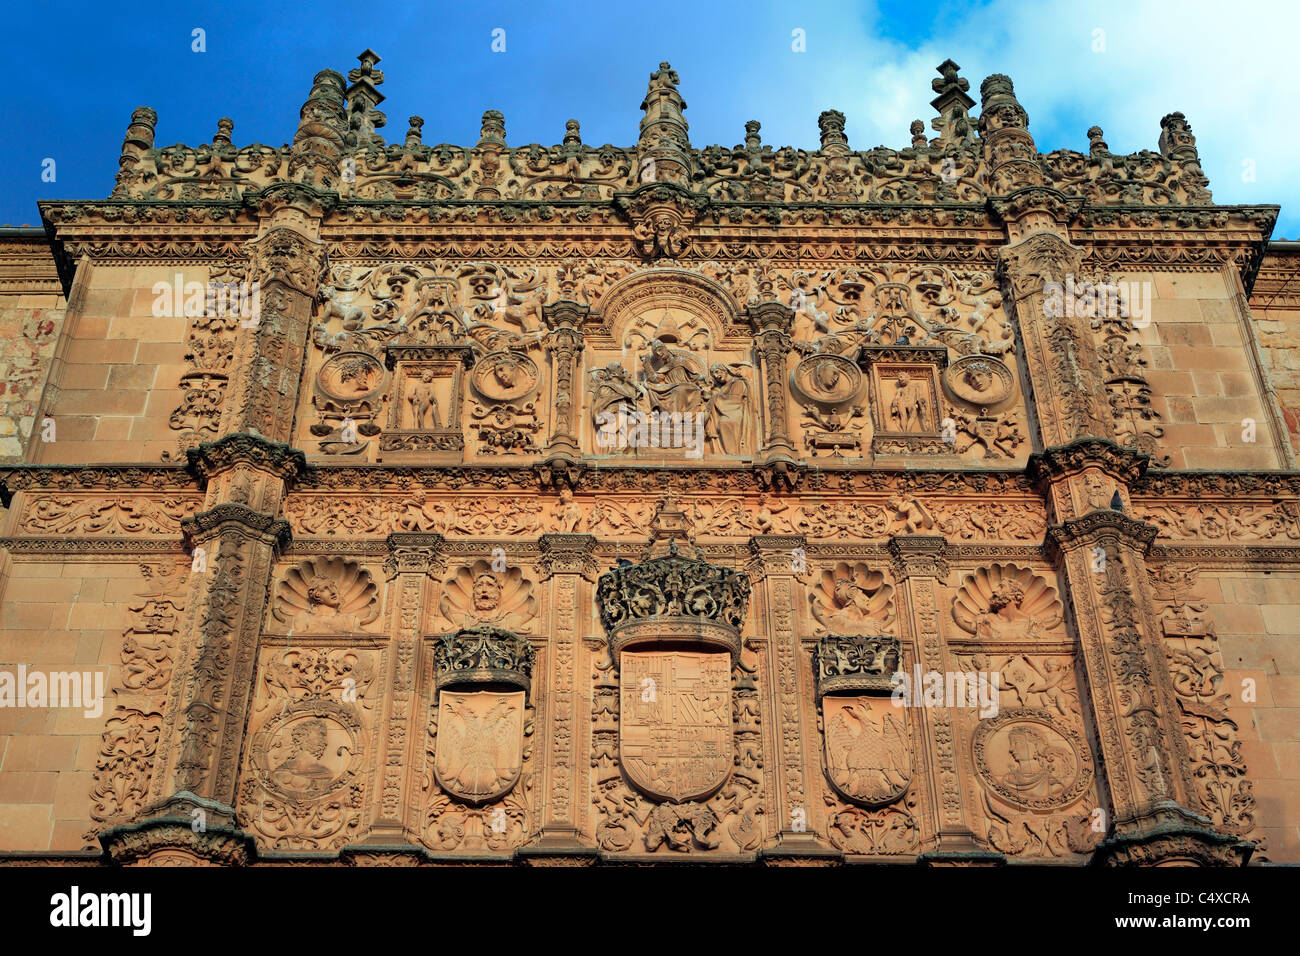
619, 650, 733, 803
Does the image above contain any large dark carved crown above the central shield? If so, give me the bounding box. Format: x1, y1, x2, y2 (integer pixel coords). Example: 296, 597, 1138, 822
595, 541, 750, 658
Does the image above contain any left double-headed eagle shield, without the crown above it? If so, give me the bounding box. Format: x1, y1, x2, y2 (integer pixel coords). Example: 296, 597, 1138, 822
433, 689, 524, 804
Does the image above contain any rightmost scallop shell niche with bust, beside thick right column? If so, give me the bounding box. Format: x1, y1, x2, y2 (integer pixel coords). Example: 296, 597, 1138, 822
953, 564, 1063, 640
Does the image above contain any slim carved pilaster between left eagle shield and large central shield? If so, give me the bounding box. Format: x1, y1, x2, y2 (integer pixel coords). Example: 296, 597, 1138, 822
525, 535, 597, 855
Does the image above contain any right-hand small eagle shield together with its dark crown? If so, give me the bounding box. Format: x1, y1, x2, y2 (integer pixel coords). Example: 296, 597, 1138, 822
813, 635, 913, 806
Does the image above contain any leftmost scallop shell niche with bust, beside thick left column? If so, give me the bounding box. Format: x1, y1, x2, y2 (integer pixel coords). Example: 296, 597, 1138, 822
273, 558, 380, 633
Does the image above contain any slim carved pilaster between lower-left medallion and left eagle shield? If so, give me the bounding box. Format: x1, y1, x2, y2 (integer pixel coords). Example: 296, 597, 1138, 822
365, 532, 446, 843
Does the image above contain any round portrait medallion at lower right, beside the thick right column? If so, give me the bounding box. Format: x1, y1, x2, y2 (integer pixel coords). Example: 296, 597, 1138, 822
974, 710, 1092, 810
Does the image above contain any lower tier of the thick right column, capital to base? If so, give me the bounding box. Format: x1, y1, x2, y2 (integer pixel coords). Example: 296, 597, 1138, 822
1030, 440, 1253, 865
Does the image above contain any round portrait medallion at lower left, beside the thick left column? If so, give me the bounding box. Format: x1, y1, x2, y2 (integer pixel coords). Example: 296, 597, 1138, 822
252, 700, 361, 803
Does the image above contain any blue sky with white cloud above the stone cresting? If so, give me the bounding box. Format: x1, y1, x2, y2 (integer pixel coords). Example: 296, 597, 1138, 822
0, 0, 1300, 238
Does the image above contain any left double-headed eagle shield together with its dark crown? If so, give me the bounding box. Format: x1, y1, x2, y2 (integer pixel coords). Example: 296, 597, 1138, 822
433, 624, 536, 804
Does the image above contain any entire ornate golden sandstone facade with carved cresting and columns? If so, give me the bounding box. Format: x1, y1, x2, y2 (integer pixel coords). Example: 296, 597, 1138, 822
0, 57, 1300, 866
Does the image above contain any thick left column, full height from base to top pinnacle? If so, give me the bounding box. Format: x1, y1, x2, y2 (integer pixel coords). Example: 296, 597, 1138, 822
105, 70, 343, 856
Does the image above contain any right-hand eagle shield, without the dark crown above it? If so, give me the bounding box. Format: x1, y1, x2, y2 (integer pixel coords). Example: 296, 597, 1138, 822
822, 695, 911, 805
